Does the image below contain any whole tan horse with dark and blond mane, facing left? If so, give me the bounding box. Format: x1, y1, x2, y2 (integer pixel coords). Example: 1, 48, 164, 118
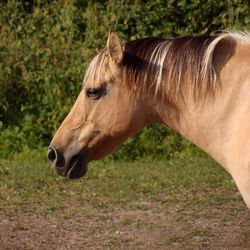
48, 31, 250, 208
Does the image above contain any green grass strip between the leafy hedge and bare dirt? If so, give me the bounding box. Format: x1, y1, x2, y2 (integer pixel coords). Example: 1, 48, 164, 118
0, 148, 241, 215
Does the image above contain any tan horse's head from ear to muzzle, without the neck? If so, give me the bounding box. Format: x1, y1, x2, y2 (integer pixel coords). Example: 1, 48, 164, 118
48, 31, 154, 178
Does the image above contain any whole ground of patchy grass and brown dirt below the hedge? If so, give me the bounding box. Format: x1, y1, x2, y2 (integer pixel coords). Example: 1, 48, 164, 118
0, 149, 250, 249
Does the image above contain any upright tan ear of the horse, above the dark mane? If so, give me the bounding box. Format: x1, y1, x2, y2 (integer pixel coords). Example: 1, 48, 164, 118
107, 30, 123, 64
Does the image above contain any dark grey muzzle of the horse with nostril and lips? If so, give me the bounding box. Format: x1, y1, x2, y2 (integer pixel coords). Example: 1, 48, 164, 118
47, 145, 88, 179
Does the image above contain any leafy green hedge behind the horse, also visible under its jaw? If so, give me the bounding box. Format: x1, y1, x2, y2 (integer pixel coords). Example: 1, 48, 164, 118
0, 0, 250, 159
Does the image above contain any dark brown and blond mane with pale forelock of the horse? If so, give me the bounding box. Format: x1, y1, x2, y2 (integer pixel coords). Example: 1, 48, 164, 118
84, 32, 250, 102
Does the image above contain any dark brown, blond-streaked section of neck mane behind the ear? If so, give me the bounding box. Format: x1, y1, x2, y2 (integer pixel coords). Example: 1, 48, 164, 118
123, 35, 217, 100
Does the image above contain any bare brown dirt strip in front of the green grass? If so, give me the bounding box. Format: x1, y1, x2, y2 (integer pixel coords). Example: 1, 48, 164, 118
0, 201, 250, 250
